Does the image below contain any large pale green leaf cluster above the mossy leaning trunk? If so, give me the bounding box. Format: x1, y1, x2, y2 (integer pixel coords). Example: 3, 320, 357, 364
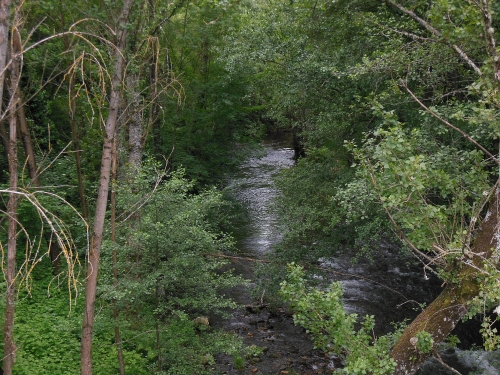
352, 121, 490, 262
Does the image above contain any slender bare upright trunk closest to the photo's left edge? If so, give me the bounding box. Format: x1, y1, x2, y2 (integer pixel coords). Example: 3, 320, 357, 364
3, 7, 21, 375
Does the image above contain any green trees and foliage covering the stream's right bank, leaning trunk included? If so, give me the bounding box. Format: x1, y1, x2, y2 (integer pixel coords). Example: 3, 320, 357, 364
233, 1, 499, 374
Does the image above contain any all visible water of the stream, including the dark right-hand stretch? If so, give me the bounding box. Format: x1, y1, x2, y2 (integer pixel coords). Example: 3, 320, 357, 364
215, 138, 496, 375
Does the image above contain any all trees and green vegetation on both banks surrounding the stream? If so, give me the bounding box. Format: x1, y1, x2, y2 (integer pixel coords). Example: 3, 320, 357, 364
0, 0, 500, 374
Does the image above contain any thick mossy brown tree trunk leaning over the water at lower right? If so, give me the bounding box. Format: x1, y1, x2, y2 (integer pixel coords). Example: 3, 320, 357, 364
391, 184, 500, 375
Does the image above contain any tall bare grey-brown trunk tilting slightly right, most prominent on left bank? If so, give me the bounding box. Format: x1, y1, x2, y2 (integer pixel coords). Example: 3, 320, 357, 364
81, 0, 134, 375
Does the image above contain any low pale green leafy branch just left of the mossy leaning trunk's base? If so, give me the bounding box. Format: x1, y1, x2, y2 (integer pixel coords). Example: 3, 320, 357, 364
281, 263, 396, 375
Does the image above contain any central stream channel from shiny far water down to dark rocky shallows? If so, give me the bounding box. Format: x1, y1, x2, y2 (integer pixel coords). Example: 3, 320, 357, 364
215, 139, 334, 374
